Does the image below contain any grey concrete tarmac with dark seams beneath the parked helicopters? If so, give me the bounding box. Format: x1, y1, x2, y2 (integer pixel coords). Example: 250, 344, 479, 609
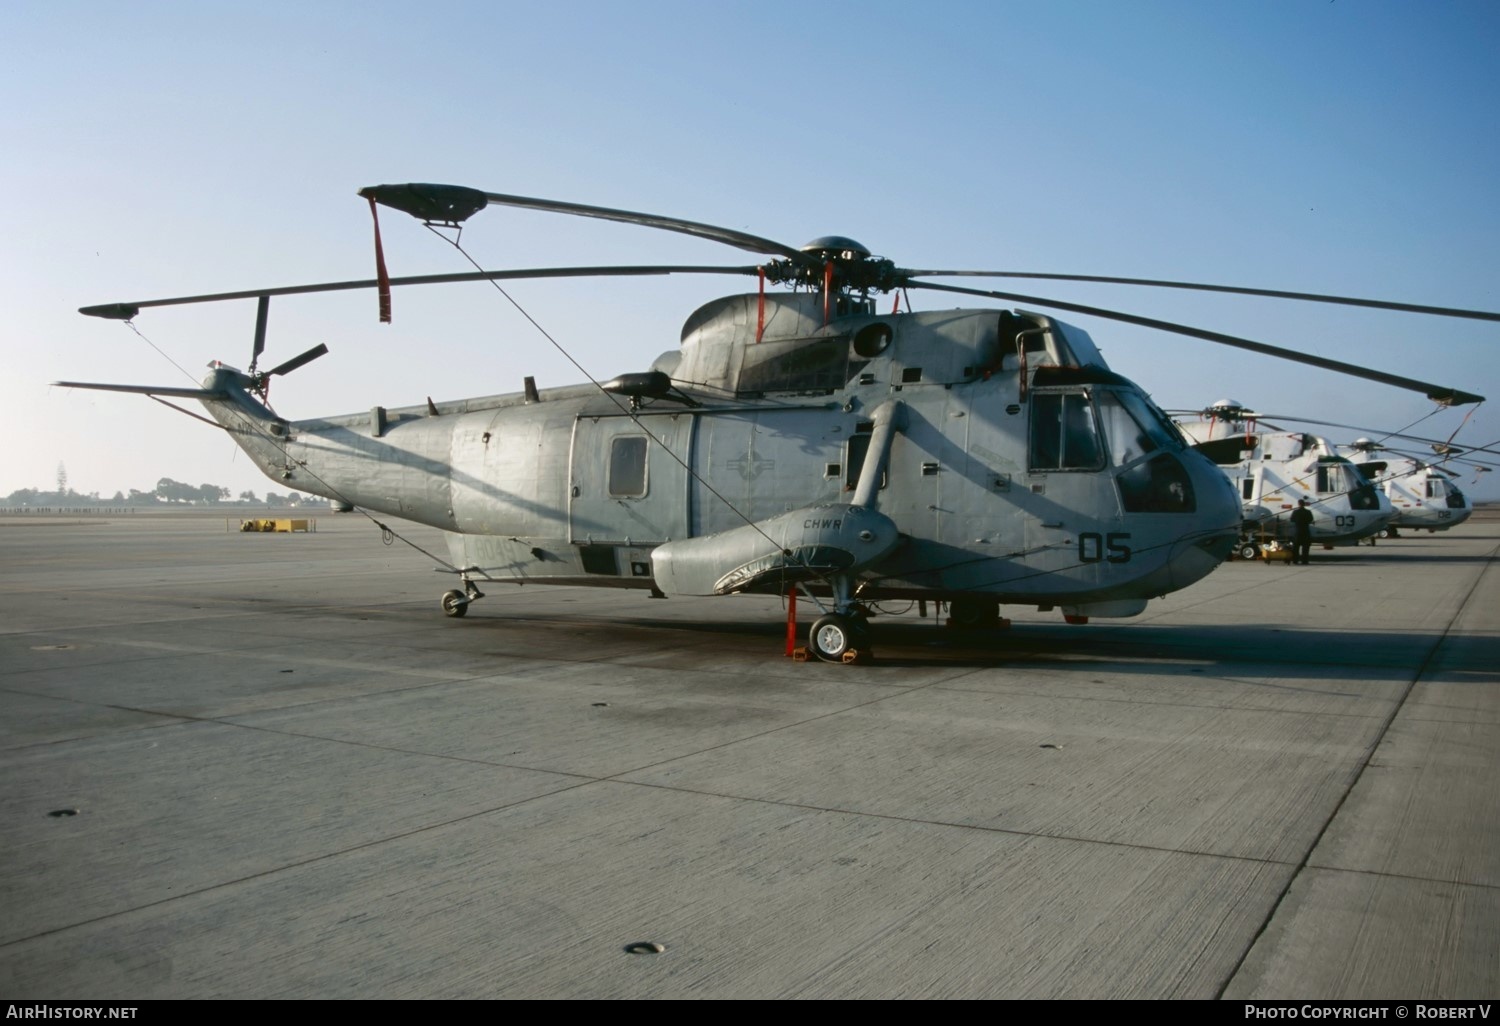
0, 510, 1500, 1001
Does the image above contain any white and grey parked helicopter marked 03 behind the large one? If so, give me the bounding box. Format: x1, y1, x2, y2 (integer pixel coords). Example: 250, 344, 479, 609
1176, 399, 1395, 560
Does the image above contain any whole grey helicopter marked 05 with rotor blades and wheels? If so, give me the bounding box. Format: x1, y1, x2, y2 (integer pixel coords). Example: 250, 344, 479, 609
59, 185, 1500, 662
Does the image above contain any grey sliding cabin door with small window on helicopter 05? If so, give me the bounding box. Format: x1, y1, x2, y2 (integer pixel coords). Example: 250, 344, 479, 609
569, 411, 695, 561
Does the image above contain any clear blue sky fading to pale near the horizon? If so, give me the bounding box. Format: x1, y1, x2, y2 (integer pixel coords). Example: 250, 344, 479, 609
0, 0, 1500, 498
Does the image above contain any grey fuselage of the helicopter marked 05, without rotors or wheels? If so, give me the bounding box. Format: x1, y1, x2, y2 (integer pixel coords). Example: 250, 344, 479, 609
204, 294, 1241, 617
